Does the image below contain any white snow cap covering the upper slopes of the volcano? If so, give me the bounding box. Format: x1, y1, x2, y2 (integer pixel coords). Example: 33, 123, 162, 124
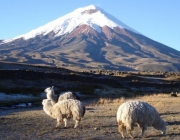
3, 5, 138, 43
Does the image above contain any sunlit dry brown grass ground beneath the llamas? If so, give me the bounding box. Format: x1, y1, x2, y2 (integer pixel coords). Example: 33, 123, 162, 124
0, 94, 180, 140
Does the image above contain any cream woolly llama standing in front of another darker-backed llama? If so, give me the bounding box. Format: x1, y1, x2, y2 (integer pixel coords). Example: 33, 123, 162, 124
42, 99, 86, 128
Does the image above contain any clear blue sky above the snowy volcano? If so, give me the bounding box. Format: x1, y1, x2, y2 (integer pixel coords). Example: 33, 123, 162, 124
0, 0, 180, 51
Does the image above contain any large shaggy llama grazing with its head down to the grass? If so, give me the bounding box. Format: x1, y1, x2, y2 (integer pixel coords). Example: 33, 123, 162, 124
117, 101, 166, 138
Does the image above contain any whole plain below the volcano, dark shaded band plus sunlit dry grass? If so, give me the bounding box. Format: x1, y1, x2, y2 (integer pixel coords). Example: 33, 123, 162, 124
0, 65, 180, 140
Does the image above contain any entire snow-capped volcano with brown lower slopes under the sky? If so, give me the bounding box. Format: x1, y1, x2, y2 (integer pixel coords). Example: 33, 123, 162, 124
0, 5, 180, 71
